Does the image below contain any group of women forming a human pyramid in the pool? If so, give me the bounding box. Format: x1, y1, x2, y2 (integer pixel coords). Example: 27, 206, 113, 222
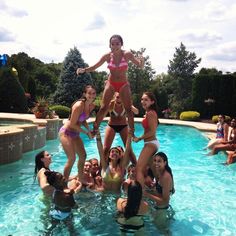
35, 35, 174, 232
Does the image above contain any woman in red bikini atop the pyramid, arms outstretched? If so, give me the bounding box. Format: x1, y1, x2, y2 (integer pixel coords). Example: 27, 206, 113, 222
76, 35, 144, 136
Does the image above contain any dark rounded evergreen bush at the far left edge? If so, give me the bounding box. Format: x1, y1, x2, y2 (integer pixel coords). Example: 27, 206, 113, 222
0, 67, 28, 113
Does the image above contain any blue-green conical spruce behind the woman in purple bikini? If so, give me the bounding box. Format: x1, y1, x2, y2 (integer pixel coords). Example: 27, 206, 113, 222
53, 47, 92, 107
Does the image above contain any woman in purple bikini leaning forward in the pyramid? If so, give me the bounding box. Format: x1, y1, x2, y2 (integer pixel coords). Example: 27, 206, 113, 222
59, 85, 96, 182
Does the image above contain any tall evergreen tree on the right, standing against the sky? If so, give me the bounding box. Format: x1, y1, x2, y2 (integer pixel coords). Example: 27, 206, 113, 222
168, 42, 201, 113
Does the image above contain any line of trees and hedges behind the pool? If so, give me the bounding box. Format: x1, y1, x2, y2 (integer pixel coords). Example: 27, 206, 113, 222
0, 43, 236, 118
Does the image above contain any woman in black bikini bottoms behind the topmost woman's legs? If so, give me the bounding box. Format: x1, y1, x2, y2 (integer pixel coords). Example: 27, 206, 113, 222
104, 92, 138, 164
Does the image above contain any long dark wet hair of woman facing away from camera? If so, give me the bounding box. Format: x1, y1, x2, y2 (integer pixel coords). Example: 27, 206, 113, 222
124, 180, 143, 218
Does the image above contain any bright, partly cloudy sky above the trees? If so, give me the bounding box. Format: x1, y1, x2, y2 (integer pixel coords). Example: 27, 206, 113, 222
0, 0, 236, 74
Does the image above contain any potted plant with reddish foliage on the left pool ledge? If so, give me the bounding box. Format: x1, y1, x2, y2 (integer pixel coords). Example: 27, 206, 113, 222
32, 97, 53, 119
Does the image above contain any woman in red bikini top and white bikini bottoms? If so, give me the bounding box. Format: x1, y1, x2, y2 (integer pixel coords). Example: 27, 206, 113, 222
133, 92, 159, 187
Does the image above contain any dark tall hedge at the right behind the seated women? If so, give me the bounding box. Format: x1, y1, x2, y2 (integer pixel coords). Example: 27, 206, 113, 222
192, 73, 236, 118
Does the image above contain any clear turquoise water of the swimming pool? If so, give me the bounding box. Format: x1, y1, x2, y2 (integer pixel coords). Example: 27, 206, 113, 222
0, 123, 236, 236
